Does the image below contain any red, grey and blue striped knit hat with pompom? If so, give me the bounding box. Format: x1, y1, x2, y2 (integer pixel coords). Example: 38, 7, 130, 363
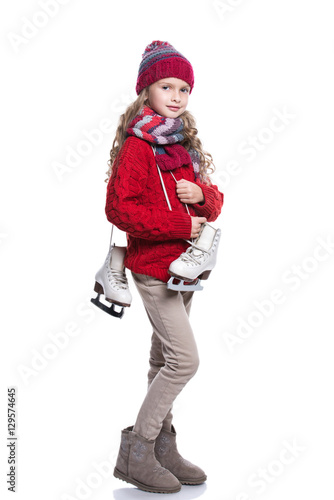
136, 40, 194, 95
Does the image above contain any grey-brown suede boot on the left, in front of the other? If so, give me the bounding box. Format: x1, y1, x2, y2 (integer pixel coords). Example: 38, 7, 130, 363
114, 426, 181, 493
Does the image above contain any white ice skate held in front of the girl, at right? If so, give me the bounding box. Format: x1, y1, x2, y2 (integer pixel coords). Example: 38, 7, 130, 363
167, 223, 221, 291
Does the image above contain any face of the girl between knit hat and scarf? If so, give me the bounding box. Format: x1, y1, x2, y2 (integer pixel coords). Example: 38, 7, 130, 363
148, 77, 190, 118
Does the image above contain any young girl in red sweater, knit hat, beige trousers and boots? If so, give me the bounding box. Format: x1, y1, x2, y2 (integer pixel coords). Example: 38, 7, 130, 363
106, 41, 223, 493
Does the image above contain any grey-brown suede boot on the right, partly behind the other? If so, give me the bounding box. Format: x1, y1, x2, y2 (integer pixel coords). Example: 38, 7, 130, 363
155, 425, 206, 484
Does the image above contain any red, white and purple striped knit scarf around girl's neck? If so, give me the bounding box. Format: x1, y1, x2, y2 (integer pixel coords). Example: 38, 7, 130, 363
126, 105, 200, 179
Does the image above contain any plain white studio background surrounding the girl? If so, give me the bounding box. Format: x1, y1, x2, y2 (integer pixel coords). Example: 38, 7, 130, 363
0, 0, 334, 500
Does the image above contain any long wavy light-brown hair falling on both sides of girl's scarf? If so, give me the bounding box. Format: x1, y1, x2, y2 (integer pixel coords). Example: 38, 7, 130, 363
105, 87, 215, 185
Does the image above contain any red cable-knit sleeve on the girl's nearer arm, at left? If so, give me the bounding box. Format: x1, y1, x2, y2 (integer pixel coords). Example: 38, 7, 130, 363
105, 137, 191, 241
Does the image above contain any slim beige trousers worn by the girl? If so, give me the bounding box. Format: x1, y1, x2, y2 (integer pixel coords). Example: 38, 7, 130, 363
132, 272, 199, 440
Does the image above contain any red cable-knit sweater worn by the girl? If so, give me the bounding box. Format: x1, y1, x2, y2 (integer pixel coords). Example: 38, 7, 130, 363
105, 136, 224, 282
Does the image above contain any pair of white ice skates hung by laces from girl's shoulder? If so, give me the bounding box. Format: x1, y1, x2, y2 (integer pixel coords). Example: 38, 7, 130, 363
91, 223, 221, 318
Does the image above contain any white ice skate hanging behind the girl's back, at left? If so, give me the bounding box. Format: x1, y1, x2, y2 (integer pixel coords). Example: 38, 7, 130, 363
91, 245, 132, 318
